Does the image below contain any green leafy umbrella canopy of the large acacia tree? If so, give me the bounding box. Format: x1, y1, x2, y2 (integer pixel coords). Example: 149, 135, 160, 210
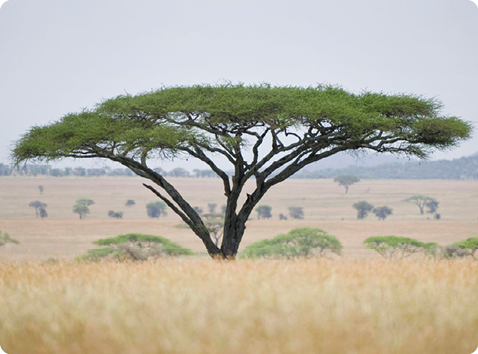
13, 84, 471, 164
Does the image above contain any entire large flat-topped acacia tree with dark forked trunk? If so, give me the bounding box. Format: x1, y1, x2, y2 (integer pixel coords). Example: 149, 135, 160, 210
13, 84, 471, 258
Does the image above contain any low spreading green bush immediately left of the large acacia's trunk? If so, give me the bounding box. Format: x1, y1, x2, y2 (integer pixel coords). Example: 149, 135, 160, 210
82, 233, 194, 260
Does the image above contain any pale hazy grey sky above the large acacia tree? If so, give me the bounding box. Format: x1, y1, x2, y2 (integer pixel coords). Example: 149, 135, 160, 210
0, 0, 478, 171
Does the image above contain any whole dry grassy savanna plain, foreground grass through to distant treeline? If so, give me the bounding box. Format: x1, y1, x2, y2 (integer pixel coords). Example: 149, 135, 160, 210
0, 177, 478, 354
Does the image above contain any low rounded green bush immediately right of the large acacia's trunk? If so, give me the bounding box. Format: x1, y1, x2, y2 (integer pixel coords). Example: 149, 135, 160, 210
242, 227, 342, 258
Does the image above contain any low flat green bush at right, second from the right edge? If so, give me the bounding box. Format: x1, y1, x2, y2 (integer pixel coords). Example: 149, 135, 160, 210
364, 236, 438, 259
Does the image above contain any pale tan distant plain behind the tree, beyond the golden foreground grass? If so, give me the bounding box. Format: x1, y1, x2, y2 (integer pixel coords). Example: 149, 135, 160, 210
0, 177, 478, 260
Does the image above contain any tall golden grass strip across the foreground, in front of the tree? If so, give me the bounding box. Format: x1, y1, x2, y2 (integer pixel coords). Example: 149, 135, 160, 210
0, 258, 478, 354
